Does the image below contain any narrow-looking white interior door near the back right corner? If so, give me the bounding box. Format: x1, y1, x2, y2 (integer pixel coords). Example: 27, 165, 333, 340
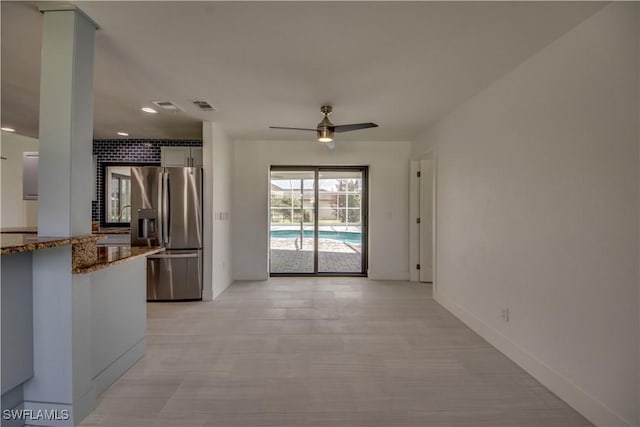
419, 159, 433, 282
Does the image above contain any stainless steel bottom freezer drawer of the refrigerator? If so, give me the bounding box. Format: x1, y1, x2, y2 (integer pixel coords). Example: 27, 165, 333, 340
147, 250, 202, 301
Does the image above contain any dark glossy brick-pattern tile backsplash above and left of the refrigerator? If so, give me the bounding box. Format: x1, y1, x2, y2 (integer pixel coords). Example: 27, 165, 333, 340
91, 139, 202, 221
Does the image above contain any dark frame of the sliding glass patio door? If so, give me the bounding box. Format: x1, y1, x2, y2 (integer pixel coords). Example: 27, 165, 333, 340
267, 165, 369, 277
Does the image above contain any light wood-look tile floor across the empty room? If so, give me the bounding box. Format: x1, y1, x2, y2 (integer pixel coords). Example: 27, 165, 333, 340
82, 278, 591, 427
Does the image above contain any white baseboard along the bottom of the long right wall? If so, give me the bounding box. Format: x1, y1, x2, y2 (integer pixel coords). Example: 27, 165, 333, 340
434, 292, 634, 427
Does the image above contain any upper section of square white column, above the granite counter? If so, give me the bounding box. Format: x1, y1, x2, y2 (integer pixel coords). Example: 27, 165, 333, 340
38, 4, 97, 237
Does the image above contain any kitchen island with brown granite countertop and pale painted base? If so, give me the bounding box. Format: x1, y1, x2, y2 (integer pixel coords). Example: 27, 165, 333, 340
0, 232, 164, 427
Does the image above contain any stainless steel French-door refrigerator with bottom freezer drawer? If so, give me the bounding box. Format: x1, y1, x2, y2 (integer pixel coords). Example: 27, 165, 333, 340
131, 166, 202, 301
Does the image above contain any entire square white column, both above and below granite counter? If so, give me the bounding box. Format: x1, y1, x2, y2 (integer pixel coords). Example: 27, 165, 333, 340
24, 3, 97, 426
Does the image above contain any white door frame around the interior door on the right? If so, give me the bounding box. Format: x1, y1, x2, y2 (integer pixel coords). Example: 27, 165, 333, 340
409, 148, 438, 292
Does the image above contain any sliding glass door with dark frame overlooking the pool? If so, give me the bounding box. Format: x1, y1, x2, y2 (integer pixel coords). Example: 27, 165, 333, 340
270, 166, 367, 275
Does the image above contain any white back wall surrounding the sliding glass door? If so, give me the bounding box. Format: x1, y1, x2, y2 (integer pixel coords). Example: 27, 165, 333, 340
233, 140, 410, 280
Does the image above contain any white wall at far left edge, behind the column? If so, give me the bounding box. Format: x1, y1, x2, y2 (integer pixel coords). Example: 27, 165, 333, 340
0, 132, 38, 228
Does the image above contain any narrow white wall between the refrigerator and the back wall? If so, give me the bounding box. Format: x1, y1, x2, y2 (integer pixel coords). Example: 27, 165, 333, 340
202, 122, 233, 300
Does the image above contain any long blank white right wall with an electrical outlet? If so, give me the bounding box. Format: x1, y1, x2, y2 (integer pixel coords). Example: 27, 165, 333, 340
413, 3, 640, 427
